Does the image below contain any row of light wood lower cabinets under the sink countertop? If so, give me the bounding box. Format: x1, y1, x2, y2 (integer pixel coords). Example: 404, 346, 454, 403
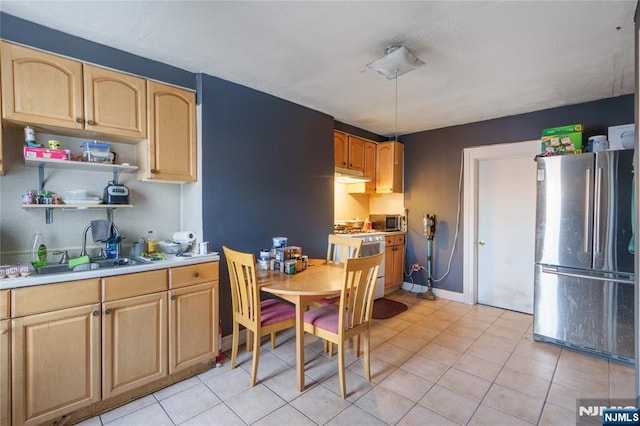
6, 262, 219, 426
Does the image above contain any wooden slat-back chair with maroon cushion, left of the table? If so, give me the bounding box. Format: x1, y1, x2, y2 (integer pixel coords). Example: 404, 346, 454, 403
222, 246, 296, 386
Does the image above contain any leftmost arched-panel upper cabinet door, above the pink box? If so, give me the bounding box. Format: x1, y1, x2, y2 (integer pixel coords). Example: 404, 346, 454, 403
2, 42, 84, 129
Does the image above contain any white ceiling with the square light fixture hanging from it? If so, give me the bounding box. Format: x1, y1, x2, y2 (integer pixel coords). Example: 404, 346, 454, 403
0, 0, 636, 136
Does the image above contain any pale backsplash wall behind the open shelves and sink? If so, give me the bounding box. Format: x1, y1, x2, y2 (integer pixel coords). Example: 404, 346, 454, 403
0, 128, 202, 264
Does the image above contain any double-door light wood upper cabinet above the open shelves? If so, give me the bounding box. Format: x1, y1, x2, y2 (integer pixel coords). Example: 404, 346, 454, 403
2, 42, 147, 141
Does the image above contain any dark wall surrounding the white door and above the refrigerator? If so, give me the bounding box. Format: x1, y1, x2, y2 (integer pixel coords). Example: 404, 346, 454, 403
400, 95, 634, 292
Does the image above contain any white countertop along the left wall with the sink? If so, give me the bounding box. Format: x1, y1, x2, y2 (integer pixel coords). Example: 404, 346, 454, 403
0, 253, 220, 290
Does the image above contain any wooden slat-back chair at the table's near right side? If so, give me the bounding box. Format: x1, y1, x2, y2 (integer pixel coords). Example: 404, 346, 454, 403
304, 253, 384, 398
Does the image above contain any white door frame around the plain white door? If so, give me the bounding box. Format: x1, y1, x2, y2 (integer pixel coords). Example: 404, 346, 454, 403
462, 139, 540, 305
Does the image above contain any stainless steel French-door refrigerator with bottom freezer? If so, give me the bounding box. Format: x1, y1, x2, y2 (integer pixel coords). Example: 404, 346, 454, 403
533, 150, 635, 363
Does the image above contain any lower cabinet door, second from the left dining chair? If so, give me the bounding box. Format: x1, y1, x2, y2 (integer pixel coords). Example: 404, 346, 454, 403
102, 291, 167, 399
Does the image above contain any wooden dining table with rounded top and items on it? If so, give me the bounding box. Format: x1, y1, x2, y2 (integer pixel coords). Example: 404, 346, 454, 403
257, 259, 344, 391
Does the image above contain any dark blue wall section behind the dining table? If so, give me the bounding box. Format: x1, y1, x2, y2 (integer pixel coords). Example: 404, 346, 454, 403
198, 75, 334, 330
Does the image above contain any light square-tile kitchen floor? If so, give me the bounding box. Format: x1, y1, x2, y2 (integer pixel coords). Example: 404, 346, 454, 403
81, 291, 635, 426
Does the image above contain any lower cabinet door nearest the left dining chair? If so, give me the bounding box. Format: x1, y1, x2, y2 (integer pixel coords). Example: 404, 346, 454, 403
169, 282, 218, 374
